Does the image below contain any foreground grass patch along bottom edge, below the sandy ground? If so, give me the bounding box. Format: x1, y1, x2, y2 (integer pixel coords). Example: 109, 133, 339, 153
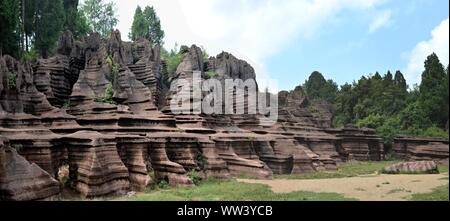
127, 179, 355, 201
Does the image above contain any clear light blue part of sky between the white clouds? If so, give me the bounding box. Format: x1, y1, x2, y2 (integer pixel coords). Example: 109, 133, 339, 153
266, 0, 449, 89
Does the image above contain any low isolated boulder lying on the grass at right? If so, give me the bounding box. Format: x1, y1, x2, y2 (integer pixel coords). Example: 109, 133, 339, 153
383, 161, 439, 174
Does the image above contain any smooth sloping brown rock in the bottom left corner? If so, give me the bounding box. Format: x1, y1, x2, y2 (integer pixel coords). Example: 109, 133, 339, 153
0, 137, 60, 201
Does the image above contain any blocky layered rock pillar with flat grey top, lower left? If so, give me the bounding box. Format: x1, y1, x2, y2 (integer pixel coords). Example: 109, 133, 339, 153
59, 131, 130, 197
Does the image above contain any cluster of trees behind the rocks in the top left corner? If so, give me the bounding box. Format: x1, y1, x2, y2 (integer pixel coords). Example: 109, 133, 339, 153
0, 0, 118, 58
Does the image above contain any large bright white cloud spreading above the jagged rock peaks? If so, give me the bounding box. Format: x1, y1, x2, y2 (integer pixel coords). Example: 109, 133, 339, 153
89, 0, 389, 91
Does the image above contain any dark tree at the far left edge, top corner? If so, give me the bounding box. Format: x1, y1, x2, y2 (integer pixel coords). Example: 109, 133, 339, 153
0, 0, 21, 56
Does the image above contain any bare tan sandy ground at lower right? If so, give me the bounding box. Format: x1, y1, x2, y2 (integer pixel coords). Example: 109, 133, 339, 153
238, 173, 449, 201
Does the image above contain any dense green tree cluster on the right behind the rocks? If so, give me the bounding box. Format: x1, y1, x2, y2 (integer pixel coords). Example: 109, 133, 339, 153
304, 53, 449, 144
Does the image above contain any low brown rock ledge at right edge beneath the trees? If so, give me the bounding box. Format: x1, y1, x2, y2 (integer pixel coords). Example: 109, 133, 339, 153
392, 137, 449, 162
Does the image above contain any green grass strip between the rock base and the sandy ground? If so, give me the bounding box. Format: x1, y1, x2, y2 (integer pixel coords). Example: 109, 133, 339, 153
275, 161, 399, 180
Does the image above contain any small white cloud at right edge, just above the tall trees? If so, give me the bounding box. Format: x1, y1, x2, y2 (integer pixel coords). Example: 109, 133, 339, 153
405, 18, 449, 85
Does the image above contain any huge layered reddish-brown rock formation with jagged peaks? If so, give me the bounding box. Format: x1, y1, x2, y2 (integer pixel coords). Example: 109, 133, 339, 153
0, 31, 390, 200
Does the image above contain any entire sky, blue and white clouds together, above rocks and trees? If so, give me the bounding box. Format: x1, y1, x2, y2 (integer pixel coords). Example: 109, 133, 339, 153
99, 0, 449, 91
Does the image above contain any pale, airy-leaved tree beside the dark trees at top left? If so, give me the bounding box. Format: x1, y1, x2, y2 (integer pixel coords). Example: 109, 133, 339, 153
81, 0, 119, 37
